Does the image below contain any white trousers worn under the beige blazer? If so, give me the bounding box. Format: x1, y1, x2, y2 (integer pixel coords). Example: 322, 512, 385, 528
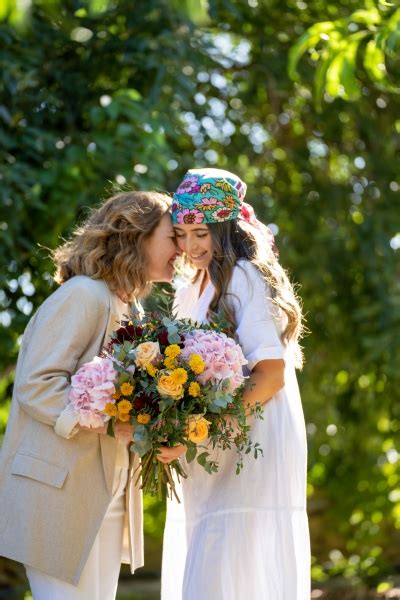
25, 468, 128, 600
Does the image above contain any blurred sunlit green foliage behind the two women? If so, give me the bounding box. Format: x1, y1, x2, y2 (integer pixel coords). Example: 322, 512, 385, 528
0, 0, 400, 600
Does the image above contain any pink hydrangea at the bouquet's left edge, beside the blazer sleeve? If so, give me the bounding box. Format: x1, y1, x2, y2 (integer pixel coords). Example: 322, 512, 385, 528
69, 356, 117, 427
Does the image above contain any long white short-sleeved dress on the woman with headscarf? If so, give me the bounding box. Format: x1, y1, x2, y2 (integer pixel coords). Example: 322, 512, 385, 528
161, 260, 310, 600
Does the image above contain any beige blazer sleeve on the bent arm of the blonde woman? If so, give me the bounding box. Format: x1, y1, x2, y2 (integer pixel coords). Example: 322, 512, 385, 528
14, 281, 108, 438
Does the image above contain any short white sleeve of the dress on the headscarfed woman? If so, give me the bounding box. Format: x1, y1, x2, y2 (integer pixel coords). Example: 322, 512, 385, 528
228, 261, 285, 370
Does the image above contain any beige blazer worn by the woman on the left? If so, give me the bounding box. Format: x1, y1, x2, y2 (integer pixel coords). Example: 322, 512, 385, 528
0, 276, 143, 584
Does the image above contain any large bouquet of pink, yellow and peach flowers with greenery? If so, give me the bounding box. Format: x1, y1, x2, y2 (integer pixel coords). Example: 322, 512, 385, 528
70, 317, 261, 497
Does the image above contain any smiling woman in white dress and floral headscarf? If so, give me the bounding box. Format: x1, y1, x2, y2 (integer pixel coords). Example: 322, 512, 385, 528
161, 169, 310, 600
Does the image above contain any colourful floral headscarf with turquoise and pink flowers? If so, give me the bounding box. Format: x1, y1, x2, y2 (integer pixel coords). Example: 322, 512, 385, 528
172, 169, 247, 225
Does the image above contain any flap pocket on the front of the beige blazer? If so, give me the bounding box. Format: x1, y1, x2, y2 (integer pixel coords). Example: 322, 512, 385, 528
11, 452, 68, 488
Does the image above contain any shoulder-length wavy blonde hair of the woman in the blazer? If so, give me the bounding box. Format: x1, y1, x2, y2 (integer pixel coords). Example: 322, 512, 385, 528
52, 192, 171, 301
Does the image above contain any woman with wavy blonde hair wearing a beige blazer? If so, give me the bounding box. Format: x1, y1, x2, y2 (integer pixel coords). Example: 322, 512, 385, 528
0, 192, 177, 600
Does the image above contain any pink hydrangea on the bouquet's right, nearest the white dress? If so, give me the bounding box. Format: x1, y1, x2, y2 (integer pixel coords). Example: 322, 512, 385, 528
181, 329, 247, 393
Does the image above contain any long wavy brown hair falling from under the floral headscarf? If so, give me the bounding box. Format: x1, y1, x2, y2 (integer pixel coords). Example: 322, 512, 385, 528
197, 220, 304, 368
